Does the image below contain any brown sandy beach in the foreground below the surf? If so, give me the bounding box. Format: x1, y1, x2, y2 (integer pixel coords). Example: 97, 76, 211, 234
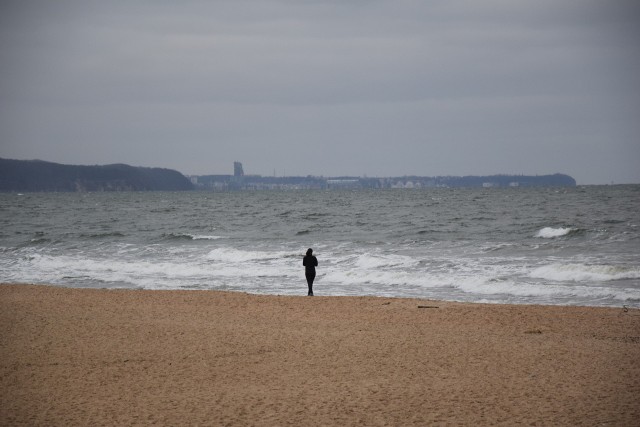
0, 285, 640, 426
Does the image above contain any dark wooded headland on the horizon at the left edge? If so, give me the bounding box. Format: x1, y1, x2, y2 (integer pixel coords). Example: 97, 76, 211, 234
0, 159, 193, 192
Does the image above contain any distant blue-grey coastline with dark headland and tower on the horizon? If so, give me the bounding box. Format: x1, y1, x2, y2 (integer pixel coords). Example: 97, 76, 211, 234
0, 158, 576, 192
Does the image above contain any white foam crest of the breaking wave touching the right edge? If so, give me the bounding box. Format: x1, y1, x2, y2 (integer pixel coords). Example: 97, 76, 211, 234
529, 264, 640, 282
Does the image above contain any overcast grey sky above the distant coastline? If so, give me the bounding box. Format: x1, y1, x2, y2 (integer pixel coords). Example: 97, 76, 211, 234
0, 0, 640, 184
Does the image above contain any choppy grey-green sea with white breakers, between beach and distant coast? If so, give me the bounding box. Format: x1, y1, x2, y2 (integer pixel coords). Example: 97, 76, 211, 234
0, 185, 640, 307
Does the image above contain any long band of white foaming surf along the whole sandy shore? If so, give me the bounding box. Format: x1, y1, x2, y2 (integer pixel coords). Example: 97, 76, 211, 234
0, 243, 640, 304
